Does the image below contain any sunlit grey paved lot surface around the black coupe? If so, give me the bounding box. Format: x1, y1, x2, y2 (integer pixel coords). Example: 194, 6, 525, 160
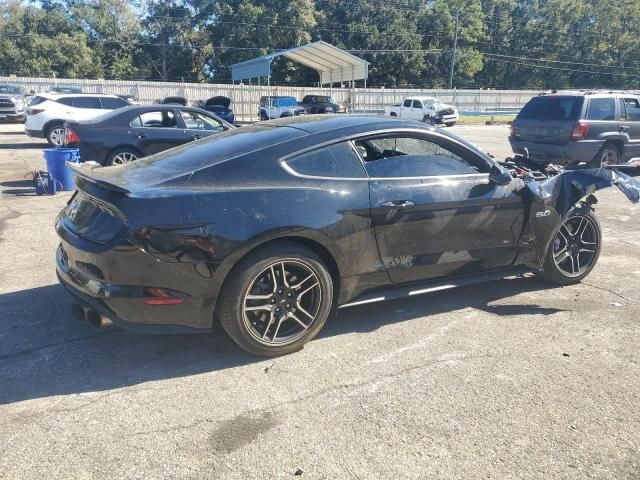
0, 125, 640, 480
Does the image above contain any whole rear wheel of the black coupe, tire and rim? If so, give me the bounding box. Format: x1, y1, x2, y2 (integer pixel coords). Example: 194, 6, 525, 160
216, 242, 333, 357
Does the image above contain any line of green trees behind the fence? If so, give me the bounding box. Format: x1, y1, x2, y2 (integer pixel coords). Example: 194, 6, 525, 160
0, 0, 640, 89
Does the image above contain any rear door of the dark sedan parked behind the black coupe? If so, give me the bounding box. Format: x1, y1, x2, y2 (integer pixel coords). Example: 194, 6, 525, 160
129, 108, 189, 156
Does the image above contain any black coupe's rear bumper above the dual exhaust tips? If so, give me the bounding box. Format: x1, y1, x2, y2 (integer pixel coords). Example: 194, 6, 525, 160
56, 242, 213, 333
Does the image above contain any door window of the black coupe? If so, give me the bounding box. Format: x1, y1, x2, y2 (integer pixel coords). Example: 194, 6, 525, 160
356, 135, 489, 178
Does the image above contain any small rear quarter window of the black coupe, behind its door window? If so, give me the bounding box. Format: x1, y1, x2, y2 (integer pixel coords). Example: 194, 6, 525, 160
287, 142, 366, 178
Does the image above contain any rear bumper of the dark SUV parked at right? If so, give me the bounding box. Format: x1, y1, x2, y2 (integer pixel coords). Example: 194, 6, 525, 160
509, 138, 604, 165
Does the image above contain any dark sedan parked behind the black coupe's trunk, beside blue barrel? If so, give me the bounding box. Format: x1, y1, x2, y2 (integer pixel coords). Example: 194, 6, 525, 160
65, 105, 235, 165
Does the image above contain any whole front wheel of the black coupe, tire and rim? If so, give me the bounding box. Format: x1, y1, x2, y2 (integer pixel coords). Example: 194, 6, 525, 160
542, 207, 602, 285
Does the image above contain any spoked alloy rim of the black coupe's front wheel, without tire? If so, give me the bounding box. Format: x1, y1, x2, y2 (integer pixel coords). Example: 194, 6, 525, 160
553, 215, 598, 278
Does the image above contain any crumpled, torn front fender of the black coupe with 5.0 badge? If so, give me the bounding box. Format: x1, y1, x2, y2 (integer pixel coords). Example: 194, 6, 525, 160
521, 168, 640, 268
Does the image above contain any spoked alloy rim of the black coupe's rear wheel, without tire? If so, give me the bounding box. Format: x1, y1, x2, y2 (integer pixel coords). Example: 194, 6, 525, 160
242, 259, 322, 346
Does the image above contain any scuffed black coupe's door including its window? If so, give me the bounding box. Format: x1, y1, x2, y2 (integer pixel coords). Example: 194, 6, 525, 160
356, 132, 523, 283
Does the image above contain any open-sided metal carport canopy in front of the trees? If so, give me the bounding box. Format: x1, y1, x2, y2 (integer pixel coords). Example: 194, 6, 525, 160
231, 41, 370, 85
